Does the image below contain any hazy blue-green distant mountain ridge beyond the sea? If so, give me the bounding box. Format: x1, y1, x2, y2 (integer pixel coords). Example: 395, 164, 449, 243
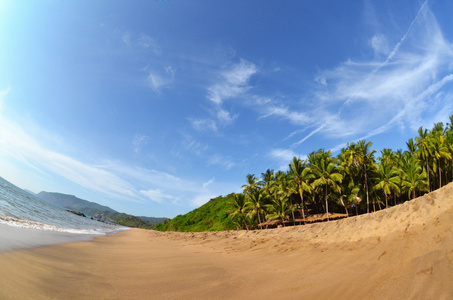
37, 192, 168, 228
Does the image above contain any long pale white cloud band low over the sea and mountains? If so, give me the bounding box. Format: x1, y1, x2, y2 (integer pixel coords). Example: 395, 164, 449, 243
0, 117, 231, 211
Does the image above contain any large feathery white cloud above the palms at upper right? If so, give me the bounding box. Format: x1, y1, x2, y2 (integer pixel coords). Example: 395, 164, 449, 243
294, 2, 453, 146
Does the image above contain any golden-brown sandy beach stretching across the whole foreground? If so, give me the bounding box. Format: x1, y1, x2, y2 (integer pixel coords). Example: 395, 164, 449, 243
0, 184, 453, 299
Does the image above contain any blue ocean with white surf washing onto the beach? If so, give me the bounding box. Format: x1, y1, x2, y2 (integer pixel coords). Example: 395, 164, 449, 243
0, 177, 127, 252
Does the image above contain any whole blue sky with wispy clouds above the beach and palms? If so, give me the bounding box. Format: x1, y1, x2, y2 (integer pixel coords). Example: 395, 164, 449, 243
0, 0, 453, 217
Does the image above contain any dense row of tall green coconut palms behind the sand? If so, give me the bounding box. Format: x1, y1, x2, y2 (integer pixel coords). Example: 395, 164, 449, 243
229, 115, 453, 229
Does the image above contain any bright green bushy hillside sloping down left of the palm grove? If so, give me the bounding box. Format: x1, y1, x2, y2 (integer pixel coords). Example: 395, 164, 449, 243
155, 194, 236, 232
